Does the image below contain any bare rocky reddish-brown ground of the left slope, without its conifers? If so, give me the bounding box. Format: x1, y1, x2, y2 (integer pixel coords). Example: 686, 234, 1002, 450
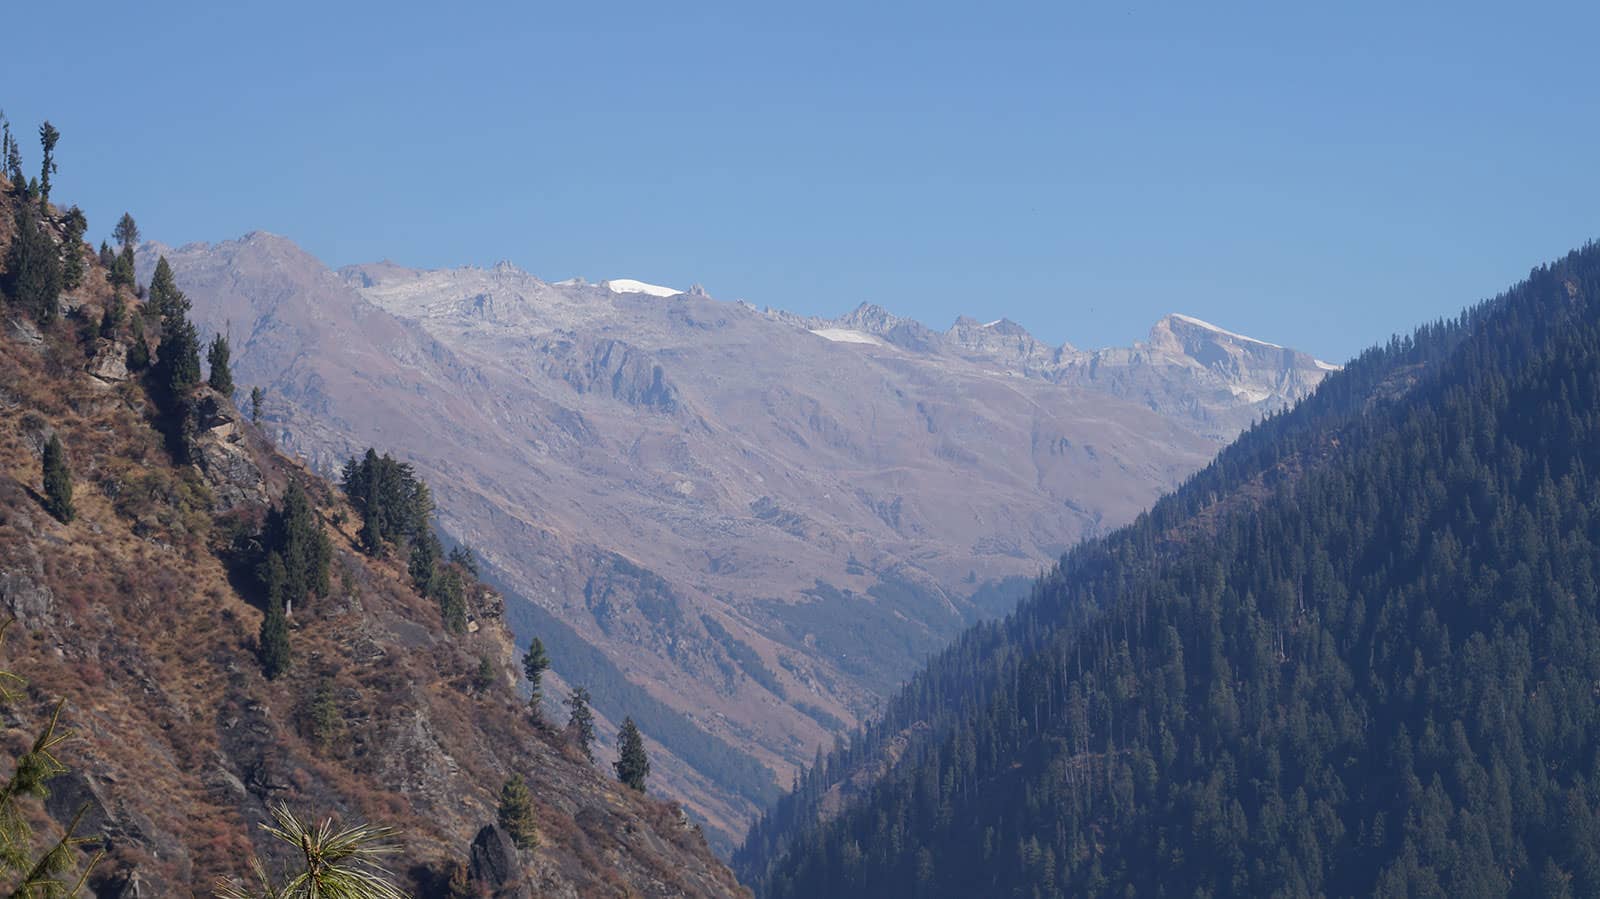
0, 179, 741, 897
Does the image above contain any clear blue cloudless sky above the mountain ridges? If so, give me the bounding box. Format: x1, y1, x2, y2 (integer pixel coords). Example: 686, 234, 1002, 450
0, 0, 1600, 358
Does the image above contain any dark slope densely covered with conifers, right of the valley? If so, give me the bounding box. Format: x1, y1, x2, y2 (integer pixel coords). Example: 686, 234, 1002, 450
736, 245, 1600, 897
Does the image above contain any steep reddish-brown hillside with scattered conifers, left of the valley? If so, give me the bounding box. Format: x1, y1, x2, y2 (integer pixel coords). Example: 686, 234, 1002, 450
0, 115, 742, 897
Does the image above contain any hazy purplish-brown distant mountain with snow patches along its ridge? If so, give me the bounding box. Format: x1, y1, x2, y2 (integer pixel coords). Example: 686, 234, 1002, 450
150, 232, 1331, 833
